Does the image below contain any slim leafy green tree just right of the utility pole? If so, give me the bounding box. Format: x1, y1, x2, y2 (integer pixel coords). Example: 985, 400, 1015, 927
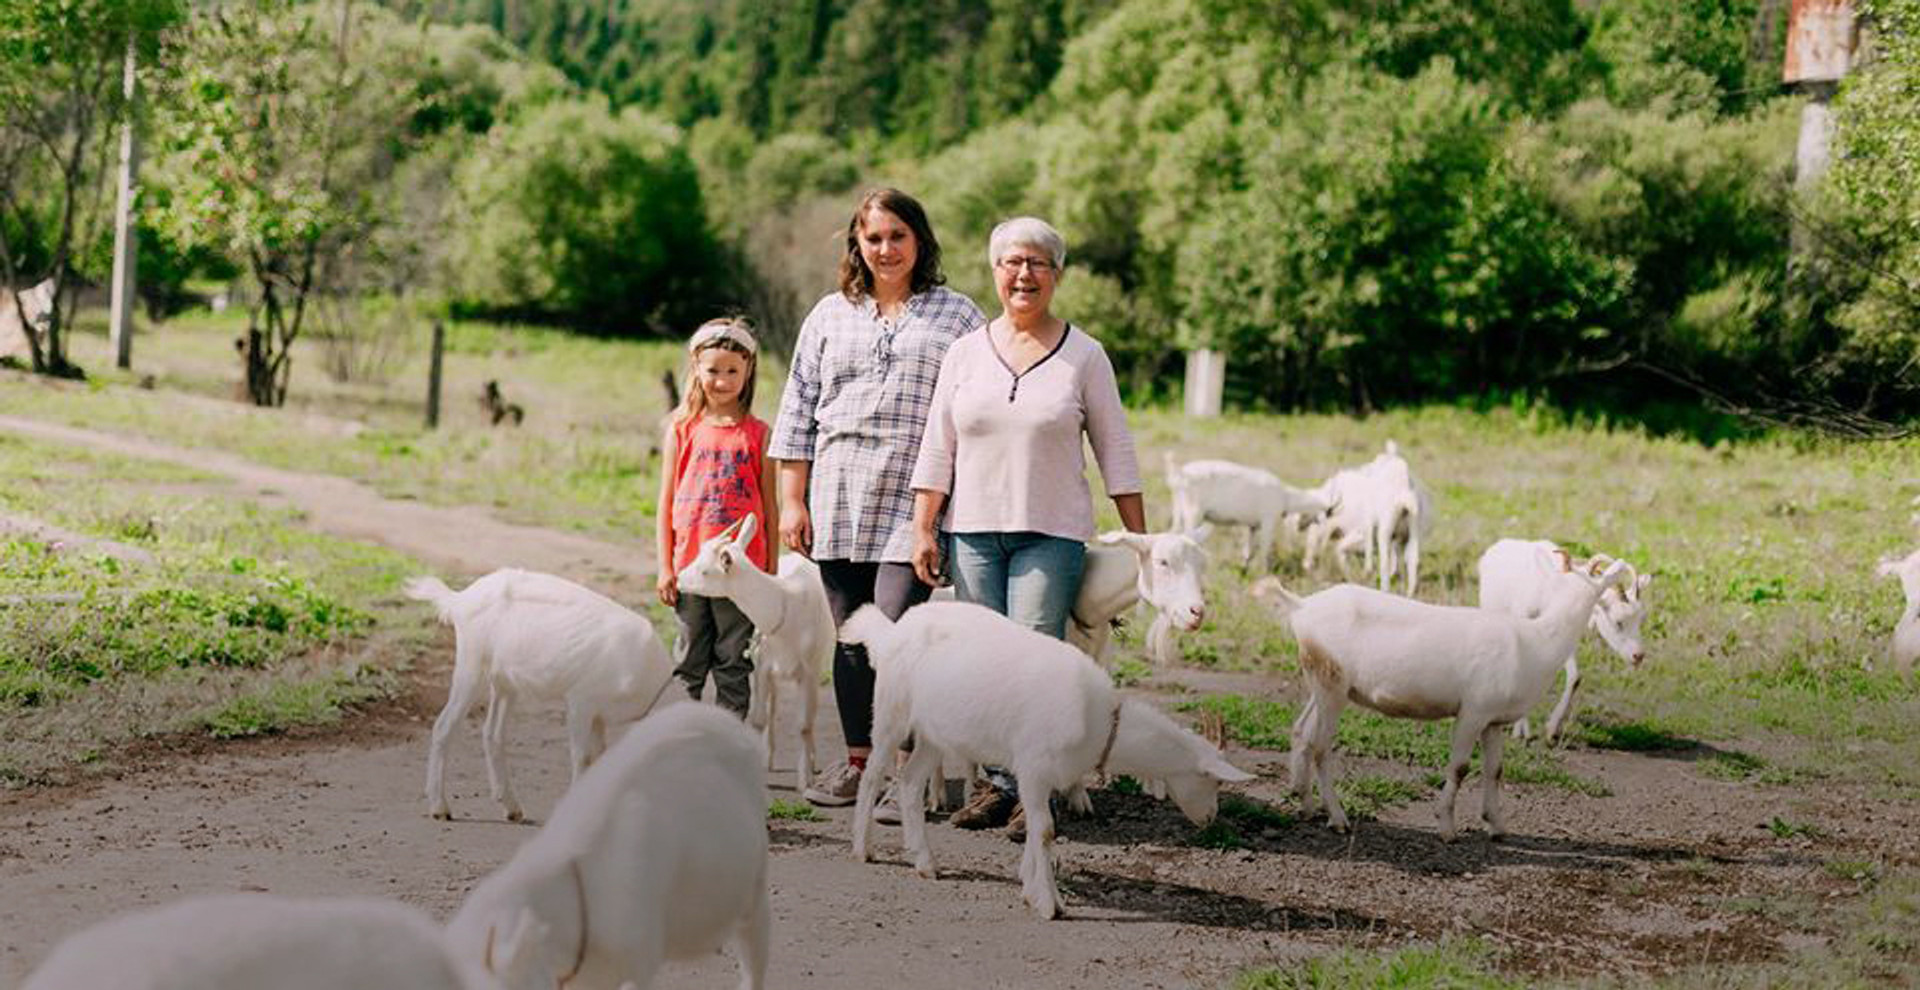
154, 0, 420, 407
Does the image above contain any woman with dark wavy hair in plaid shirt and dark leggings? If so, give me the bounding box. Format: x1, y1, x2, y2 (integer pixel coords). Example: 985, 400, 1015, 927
768, 188, 987, 821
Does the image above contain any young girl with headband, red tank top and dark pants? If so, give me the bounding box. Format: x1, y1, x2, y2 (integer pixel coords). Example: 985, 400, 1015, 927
659, 318, 780, 718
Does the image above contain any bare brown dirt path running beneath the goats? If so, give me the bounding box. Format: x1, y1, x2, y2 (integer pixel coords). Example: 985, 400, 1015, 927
0, 418, 1920, 990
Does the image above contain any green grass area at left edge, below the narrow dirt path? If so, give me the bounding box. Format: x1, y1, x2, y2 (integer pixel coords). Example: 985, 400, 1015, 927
0, 436, 422, 785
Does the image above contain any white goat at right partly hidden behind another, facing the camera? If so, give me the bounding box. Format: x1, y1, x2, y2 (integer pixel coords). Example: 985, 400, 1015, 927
1480, 539, 1653, 743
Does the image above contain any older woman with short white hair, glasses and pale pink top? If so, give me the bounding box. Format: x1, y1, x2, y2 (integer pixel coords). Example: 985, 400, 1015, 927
912, 217, 1146, 827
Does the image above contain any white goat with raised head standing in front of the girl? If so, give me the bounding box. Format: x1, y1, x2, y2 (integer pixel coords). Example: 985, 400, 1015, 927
680, 516, 835, 790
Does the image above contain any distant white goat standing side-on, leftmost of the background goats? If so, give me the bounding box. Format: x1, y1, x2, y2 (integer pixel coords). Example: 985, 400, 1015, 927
1165, 451, 1331, 570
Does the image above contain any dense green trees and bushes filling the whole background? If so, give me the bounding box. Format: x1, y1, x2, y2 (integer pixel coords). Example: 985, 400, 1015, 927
0, 0, 1920, 426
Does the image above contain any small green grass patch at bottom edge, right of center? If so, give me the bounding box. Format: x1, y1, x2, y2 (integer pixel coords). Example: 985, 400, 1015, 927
1231, 938, 1530, 990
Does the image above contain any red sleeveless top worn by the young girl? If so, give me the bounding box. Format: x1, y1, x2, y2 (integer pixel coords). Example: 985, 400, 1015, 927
674, 414, 772, 574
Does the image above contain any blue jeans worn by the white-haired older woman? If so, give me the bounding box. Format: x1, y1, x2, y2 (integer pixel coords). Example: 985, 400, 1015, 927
947, 533, 1087, 796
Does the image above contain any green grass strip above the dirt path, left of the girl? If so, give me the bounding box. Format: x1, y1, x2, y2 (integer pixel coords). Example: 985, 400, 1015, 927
28, 313, 721, 541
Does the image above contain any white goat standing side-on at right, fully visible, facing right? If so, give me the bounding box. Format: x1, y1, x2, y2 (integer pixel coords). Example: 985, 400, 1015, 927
1269, 554, 1626, 838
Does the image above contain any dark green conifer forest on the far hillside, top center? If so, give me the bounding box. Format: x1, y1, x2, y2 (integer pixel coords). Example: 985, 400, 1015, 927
380, 0, 1104, 150
